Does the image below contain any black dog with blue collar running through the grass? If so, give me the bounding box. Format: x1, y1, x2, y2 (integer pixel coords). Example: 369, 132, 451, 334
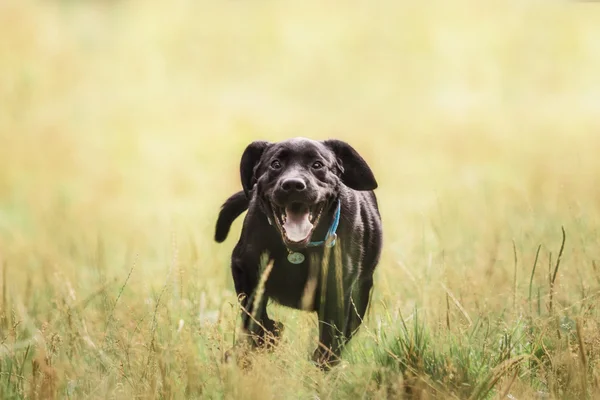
215, 138, 382, 367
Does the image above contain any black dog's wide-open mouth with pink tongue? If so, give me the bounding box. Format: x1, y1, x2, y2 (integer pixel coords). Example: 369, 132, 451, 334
271, 202, 325, 247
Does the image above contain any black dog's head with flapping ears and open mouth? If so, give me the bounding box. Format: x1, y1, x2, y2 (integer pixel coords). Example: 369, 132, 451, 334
240, 138, 377, 249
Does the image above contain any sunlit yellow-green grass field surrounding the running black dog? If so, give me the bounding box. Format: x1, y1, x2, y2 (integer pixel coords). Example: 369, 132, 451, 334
0, 0, 600, 399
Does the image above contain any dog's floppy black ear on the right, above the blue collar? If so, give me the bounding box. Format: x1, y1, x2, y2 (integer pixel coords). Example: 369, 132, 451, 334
323, 139, 377, 190
